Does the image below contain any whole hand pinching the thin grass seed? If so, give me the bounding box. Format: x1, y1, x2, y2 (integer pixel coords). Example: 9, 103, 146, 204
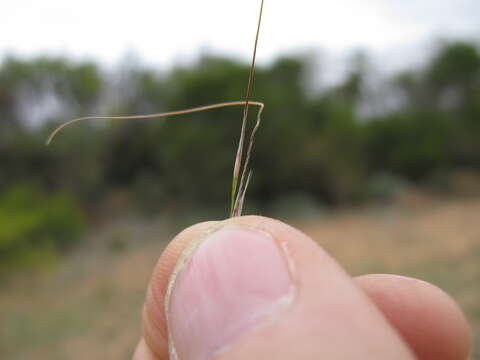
134, 216, 471, 360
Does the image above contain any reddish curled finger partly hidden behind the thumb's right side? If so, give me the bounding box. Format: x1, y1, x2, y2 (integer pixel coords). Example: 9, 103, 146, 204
355, 274, 471, 360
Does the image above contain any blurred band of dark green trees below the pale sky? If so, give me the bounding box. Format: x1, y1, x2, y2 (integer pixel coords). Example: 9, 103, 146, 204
0, 42, 480, 218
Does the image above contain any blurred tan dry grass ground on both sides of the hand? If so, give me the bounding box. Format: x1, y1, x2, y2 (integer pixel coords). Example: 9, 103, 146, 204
0, 197, 480, 360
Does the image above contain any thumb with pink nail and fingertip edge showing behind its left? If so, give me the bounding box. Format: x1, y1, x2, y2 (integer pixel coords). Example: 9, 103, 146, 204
140, 217, 413, 360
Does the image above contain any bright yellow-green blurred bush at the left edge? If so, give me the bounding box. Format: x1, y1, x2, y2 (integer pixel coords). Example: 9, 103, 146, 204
0, 185, 85, 272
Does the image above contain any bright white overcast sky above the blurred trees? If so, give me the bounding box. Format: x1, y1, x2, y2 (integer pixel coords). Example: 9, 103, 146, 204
0, 0, 480, 75
